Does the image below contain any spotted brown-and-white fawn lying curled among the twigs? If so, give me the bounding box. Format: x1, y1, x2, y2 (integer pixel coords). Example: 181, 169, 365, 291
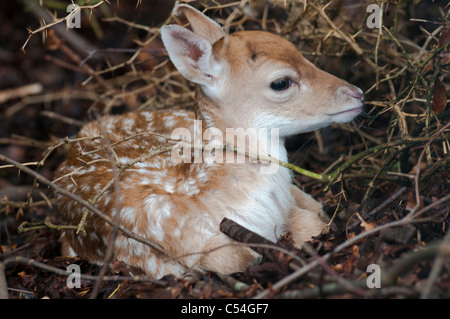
57, 5, 364, 278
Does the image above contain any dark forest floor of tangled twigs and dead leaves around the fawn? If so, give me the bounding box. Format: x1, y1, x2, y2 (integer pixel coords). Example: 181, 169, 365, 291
0, 0, 450, 299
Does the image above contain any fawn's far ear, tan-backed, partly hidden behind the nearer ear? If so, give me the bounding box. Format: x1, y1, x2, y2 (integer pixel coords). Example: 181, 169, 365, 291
173, 4, 225, 44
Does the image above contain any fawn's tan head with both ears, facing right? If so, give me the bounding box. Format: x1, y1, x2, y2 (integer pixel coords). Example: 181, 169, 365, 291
161, 5, 364, 136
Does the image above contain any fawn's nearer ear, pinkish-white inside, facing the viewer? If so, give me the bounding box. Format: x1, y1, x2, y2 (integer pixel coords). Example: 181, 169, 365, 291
161, 25, 222, 89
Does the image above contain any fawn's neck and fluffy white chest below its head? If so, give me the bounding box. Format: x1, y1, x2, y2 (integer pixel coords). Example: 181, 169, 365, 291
192, 90, 293, 238
